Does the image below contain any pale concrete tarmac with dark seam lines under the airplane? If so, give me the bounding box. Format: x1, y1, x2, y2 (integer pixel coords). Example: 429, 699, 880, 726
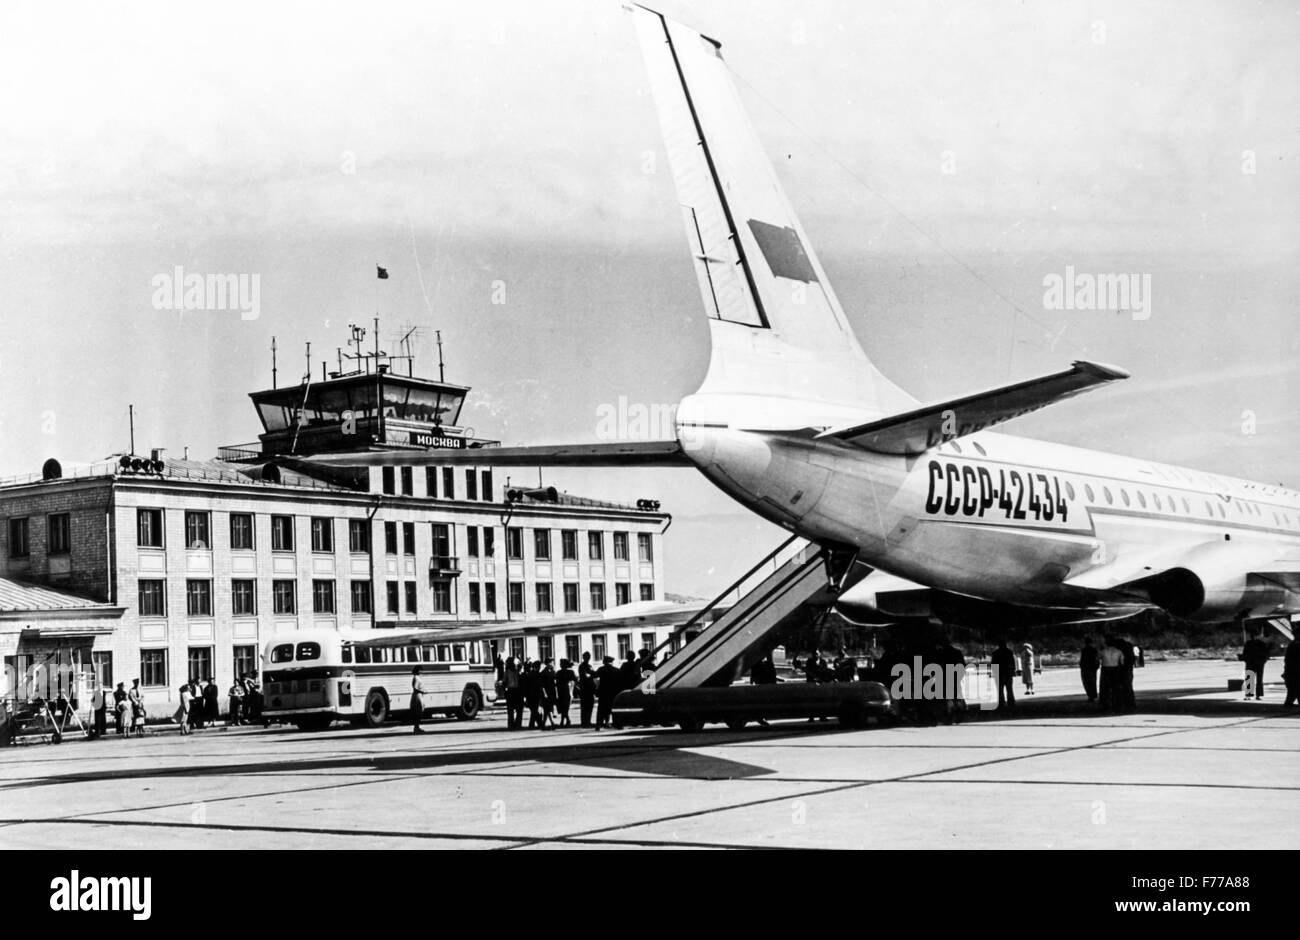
0, 660, 1300, 849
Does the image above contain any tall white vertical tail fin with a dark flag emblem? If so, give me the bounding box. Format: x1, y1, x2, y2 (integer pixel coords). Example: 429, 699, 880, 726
632, 7, 915, 415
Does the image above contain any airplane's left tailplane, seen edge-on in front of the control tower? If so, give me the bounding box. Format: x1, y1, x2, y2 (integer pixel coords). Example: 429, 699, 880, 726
304, 441, 692, 467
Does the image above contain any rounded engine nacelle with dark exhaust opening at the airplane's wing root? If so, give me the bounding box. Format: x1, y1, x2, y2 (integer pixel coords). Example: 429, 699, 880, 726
1138, 541, 1290, 623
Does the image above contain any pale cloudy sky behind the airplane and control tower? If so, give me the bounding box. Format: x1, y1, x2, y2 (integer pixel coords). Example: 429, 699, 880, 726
0, 0, 1300, 595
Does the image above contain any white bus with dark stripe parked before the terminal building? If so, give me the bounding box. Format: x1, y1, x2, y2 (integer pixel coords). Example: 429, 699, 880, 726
261, 631, 497, 731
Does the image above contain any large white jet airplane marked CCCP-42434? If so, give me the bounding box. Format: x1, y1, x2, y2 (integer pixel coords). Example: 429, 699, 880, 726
315, 5, 1300, 637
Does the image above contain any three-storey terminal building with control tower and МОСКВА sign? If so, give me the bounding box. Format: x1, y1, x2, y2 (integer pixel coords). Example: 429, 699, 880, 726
0, 338, 690, 707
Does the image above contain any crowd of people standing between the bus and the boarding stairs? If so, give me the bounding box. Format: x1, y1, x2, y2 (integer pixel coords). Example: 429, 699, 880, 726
486, 649, 655, 731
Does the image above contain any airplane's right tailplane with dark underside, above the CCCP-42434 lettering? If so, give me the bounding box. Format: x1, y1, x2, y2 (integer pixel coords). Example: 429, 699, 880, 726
818, 360, 1128, 456
